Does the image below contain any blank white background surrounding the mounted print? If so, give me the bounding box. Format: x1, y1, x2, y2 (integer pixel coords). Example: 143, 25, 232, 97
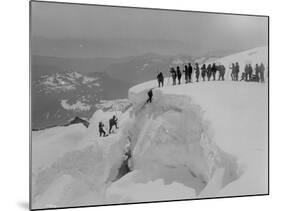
0, 0, 281, 211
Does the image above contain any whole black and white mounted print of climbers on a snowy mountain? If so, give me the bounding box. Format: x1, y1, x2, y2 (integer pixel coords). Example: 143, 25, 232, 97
29, 1, 269, 210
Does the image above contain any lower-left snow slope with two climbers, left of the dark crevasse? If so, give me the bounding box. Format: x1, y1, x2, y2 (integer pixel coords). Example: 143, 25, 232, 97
32, 106, 132, 209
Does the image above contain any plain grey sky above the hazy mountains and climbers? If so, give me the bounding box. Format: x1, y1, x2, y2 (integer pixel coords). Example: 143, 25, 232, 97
31, 2, 268, 56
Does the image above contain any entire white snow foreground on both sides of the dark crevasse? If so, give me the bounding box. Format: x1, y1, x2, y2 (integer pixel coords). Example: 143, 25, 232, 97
32, 47, 268, 209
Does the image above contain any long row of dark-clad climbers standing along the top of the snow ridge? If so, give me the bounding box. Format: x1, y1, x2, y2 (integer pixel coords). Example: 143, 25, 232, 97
157, 62, 265, 87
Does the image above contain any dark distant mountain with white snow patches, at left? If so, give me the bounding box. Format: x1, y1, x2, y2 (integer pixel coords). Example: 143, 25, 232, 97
32, 72, 130, 130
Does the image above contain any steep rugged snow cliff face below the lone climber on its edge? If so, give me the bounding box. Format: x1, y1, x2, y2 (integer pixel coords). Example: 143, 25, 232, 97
107, 85, 242, 202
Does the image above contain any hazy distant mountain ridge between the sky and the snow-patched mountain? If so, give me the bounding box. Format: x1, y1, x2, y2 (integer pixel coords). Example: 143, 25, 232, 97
32, 53, 193, 85
